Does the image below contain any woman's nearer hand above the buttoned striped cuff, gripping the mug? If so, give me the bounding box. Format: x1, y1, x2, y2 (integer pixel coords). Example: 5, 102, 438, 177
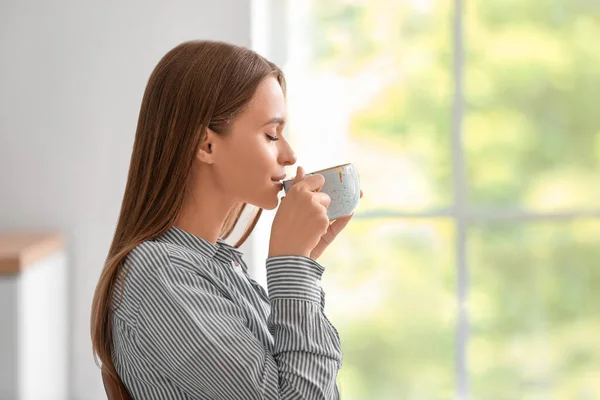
269, 167, 330, 257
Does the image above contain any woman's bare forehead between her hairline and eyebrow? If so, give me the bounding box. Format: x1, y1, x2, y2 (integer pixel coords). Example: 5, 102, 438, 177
240, 76, 286, 125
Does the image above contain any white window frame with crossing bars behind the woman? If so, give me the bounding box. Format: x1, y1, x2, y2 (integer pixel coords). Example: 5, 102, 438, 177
249, 0, 600, 400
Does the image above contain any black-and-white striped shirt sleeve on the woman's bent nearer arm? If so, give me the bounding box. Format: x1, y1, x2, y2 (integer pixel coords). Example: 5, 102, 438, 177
136, 248, 342, 400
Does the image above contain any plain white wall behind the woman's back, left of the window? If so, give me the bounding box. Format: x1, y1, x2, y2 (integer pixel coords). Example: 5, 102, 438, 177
0, 0, 250, 400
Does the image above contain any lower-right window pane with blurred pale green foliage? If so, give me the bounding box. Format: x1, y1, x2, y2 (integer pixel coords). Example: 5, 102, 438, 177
468, 220, 600, 399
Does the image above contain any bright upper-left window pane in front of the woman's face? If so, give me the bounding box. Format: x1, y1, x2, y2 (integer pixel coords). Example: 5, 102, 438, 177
285, 0, 452, 210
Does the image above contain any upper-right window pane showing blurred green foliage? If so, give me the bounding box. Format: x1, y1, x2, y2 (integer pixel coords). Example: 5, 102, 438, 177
465, 0, 600, 211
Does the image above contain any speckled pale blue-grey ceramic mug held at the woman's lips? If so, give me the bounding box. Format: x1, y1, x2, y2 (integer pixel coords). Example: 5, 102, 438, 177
283, 163, 360, 220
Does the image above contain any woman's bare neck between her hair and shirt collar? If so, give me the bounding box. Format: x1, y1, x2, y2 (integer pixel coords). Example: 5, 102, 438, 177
175, 169, 235, 244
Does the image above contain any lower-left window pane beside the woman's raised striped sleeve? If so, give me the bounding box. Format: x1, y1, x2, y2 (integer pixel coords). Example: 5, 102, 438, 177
319, 219, 456, 400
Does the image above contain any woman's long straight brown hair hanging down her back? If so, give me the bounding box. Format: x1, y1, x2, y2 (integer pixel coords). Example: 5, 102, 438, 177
91, 41, 285, 390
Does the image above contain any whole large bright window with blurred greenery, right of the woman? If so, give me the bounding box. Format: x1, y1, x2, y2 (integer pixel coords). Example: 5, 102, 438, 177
255, 0, 600, 400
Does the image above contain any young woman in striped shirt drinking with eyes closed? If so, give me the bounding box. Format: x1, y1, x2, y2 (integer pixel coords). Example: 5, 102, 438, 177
91, 41, 358, 400
